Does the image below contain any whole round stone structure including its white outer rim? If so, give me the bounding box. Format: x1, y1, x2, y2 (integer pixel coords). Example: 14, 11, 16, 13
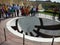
6, 16, 60, 42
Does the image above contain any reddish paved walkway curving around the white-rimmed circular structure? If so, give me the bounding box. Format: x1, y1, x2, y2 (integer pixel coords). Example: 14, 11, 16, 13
0, 13, 60, 45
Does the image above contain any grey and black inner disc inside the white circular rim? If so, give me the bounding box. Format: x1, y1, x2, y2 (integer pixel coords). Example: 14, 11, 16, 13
17, 17, 60, 38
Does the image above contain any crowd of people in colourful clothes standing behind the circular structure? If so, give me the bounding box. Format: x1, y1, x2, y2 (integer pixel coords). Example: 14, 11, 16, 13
0, 4, 38, 18
